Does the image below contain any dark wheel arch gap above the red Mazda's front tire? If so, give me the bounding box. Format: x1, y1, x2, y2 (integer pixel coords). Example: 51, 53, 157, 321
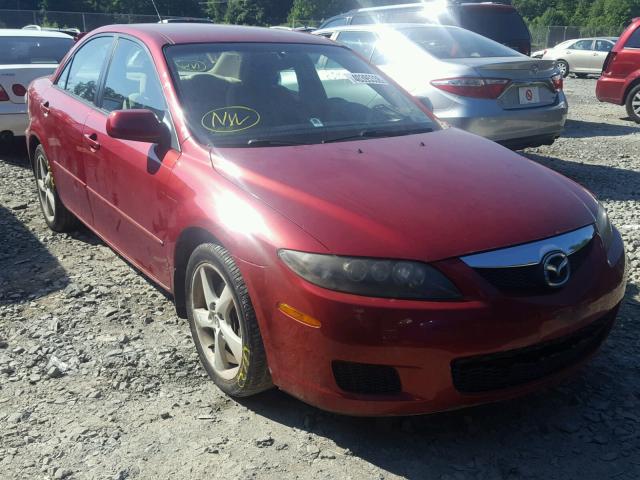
173, 227, 224, 318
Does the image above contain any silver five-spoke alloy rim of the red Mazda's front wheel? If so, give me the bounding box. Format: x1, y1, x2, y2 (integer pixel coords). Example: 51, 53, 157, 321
191, 263, 243, 380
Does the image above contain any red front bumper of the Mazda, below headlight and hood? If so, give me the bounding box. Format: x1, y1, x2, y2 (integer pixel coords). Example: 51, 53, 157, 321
241, 227, 625, 416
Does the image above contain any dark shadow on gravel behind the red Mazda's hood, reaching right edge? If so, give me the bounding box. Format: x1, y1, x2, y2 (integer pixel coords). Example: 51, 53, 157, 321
522, 152, 640, 201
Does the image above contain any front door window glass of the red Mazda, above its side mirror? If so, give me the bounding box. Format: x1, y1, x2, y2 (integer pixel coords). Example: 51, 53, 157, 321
102, 38, 168, 121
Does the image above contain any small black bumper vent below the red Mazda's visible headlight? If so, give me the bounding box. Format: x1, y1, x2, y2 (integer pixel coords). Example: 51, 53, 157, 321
332, 361, 401, 395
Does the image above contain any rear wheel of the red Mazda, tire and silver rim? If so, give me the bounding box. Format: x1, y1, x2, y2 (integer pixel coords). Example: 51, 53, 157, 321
33, 145, 77, 232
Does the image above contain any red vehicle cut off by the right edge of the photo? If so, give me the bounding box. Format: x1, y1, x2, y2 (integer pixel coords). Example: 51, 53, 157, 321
596, 18, 640, 123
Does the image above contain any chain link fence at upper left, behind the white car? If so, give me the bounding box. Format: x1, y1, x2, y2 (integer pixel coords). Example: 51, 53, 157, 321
0, 10, 205, 32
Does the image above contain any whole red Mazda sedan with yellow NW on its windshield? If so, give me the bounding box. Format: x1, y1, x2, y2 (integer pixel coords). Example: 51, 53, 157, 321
27, 24, 626, 415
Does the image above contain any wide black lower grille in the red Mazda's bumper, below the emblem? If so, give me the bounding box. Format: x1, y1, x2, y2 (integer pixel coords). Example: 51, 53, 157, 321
451, 314, 614, 393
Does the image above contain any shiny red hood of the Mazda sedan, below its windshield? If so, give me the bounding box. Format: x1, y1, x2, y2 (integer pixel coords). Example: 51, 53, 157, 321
212, 129, 594, 261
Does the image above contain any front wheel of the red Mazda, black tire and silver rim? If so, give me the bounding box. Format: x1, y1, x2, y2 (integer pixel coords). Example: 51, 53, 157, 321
185, 243, 273, 397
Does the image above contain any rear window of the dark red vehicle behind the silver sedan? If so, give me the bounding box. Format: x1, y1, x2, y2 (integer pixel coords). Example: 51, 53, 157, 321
460, 6, 530, 43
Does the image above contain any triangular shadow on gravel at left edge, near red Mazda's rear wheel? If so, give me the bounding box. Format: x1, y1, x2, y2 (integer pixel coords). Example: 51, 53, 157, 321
0, 206, 69, 305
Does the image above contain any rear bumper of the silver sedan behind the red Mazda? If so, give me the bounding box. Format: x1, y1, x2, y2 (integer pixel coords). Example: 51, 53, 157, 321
435, 93, 569, 146
